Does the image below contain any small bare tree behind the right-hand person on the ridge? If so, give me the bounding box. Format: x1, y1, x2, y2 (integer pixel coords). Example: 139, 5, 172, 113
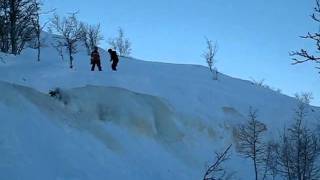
108, 27, 132, 56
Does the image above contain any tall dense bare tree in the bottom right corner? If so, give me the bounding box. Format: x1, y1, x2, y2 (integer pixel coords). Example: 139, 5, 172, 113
278, 93, 320, 180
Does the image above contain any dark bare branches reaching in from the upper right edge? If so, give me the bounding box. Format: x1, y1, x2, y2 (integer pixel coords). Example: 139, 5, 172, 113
290, 0, 320, 73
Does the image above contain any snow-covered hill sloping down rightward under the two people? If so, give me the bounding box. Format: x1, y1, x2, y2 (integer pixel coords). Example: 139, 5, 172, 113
0, 35, 320, 180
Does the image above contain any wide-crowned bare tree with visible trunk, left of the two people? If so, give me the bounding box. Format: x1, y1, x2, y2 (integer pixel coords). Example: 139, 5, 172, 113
50, 13, 83, 68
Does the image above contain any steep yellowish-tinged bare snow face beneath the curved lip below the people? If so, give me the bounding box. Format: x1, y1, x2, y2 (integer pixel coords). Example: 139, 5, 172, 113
57, 86, 183, 142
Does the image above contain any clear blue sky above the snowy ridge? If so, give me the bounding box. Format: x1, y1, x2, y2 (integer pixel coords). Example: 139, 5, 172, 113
42, 0, 320, 106
